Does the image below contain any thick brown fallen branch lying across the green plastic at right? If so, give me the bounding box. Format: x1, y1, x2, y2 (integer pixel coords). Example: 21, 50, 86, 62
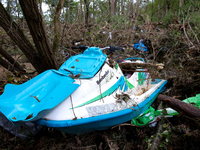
158, 94, 200, 119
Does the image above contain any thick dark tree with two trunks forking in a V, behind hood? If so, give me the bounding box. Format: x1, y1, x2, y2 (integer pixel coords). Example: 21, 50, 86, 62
0, 0, 57, 73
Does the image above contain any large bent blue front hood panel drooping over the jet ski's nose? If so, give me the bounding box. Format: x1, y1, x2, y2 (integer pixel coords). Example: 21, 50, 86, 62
0, 70, 79, 126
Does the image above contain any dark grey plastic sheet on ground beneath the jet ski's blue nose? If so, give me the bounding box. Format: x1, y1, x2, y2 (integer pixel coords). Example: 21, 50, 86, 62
0, 112, 44, 138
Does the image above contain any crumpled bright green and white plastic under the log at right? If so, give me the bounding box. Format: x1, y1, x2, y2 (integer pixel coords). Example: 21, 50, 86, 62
131, 94, 200, 127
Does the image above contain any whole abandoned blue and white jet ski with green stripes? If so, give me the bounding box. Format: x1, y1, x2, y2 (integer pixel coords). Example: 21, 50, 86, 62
0, 46, 167, 134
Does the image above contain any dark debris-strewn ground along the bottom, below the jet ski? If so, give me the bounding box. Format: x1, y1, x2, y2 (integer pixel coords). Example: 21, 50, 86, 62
0, 117, 200, 150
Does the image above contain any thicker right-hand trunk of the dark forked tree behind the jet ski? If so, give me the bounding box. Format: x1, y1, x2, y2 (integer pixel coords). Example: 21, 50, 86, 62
19, 0, 57, 72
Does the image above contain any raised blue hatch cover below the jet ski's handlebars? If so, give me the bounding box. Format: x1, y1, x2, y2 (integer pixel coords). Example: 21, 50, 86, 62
59, 47, 107, 79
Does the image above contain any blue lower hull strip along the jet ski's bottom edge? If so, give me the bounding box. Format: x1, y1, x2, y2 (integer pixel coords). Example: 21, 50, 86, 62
36, 81, 167, 134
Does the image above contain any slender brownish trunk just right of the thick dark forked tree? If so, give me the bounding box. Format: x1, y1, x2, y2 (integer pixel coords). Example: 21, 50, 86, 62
53, 0, 64, 52
